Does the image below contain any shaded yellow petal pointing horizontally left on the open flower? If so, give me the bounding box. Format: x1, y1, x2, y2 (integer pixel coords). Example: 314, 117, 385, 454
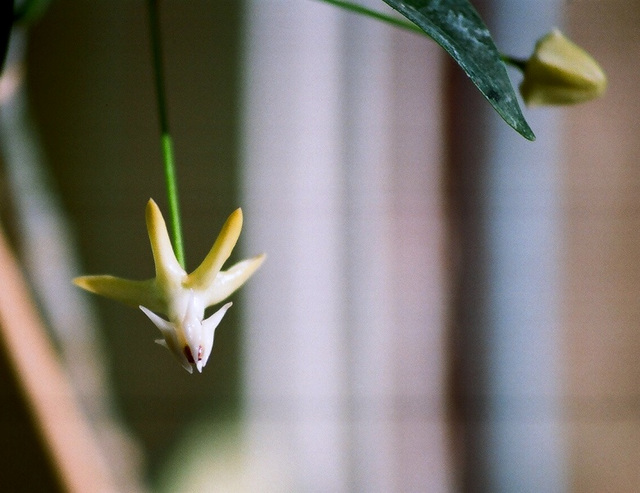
73, 276, 166, 313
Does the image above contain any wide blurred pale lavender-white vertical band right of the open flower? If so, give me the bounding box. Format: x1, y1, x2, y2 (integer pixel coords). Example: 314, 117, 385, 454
243, 0, 455, 493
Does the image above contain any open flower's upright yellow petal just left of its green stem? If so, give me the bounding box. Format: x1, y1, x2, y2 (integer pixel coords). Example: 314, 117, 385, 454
146, 199, 186, 282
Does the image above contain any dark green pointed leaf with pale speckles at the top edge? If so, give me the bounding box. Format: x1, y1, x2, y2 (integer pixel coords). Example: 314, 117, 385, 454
383, 0, 535, 140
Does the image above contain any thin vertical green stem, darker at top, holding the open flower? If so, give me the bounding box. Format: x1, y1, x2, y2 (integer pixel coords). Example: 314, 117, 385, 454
148, 0, 185, 268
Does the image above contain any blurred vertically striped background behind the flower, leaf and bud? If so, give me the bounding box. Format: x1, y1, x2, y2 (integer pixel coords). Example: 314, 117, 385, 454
0, 0, 640, 492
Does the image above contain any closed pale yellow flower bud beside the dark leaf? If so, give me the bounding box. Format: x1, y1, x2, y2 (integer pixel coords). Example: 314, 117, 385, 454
520, 30, 607, 106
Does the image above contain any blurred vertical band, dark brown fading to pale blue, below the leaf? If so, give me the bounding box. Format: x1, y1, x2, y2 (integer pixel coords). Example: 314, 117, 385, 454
448, 0, 567, 493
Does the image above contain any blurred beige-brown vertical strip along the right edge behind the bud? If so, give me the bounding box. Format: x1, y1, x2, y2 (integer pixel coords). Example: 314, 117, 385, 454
564, 0, 640, 493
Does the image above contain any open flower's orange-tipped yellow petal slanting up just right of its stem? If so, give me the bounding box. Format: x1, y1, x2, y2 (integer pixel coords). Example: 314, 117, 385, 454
185, 209, 242, 290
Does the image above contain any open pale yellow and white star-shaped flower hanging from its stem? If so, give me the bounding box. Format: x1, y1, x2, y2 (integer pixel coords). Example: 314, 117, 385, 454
73, 199, 265, 373
